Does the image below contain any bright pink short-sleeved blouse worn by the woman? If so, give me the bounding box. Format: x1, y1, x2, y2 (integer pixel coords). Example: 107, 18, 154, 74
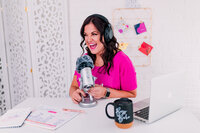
74, 51, 137, 91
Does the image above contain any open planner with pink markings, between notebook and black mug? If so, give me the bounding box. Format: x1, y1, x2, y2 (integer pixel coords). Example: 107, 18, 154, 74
25, 105, 80, 130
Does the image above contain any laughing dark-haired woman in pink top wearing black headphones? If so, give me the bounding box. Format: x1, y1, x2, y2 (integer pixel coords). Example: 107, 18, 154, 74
69, 14, 137, 103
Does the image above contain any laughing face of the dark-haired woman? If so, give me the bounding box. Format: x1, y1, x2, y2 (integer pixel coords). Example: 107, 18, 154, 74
84, 23, 104, 55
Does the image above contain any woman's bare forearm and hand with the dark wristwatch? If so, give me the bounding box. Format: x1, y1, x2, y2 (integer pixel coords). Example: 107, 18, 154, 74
89, 84, 137, 99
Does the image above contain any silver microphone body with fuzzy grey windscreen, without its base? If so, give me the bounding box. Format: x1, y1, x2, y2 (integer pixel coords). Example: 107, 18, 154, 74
76, 55, 95, 92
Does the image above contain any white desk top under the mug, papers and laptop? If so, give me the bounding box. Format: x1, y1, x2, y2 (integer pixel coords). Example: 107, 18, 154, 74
0, 98, 200, 133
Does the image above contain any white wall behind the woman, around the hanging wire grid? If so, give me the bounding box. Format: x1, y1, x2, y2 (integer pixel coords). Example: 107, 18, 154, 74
69, 0, 200, 118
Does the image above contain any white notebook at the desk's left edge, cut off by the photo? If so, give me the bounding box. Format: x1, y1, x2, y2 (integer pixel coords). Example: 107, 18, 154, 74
0, 108, 31, 128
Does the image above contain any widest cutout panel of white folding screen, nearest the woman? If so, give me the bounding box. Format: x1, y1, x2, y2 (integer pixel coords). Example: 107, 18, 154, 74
27, 0, 70, 98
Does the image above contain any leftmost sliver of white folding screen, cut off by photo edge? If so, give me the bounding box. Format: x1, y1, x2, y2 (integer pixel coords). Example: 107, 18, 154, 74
0, 1, 10, 115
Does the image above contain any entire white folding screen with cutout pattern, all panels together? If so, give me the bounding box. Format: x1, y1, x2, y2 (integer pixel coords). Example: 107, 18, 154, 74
0, 0, 70, 110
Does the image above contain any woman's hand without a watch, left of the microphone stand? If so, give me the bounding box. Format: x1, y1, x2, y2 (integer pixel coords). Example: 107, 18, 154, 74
71, 89, 86, 104
